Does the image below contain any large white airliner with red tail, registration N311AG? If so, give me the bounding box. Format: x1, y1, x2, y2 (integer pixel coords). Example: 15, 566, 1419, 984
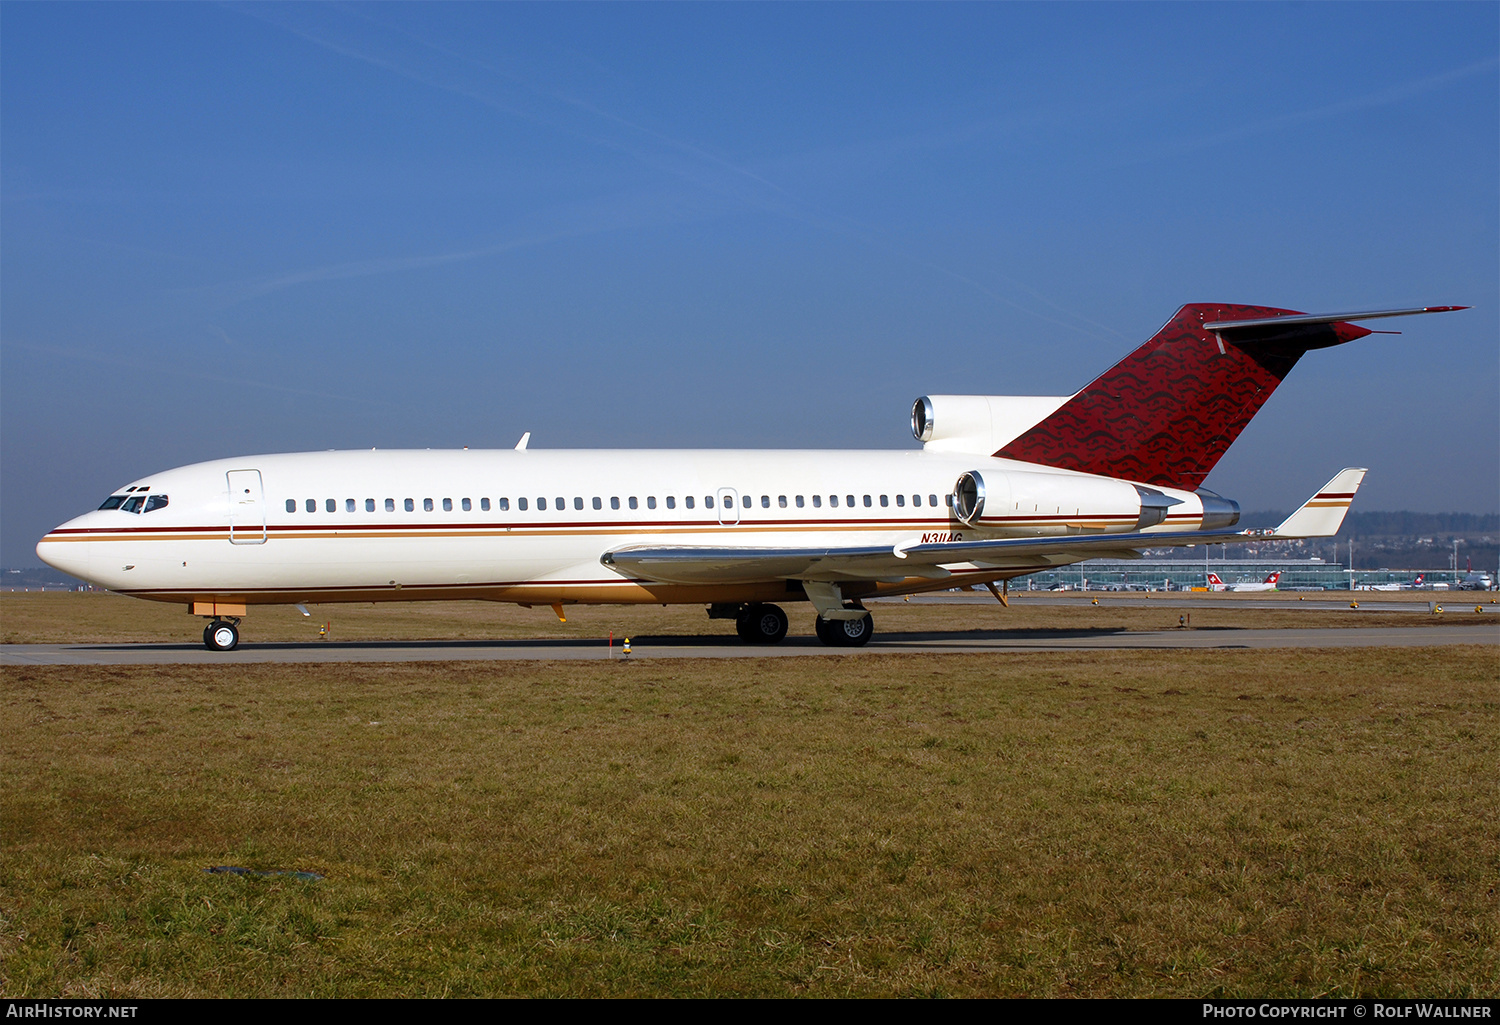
36, 303, 1464, 650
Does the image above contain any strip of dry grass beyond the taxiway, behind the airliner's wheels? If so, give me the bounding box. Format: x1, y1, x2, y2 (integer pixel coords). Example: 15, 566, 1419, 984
0, 591, 1482, 644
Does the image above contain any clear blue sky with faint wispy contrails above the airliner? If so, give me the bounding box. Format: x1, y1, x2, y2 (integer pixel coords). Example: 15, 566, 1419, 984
0, 3, 1500, 566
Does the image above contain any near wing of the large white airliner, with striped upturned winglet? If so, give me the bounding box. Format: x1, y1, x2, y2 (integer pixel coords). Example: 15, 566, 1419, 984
600, 468, 1365, 584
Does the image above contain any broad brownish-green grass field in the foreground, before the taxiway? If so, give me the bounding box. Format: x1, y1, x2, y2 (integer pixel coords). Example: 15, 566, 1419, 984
0, 633, 1500, 996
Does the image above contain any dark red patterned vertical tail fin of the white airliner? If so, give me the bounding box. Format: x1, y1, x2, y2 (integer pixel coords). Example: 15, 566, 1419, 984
995, 303, 1370, 491
